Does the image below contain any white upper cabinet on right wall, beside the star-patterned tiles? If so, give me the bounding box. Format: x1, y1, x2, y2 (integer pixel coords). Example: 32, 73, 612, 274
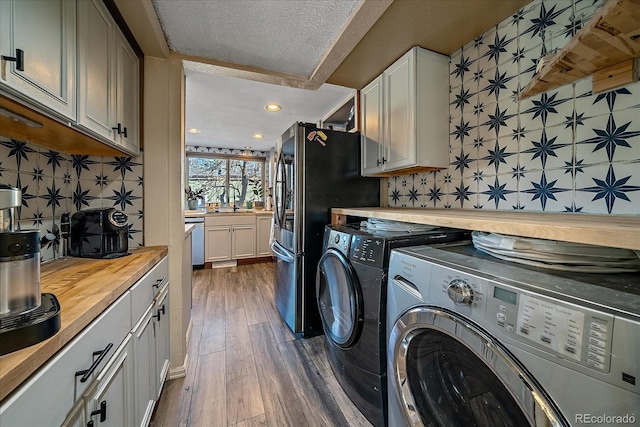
361, 47, 449, 176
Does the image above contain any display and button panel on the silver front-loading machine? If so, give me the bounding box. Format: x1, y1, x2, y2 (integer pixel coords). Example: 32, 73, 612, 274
486, 284, 613, 372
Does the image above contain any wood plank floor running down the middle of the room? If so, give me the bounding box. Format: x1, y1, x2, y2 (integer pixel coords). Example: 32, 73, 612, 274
151, 263, 370, 427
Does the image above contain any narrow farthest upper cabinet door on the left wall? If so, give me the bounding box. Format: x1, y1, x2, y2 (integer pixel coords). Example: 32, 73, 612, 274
116, 29, 140, 154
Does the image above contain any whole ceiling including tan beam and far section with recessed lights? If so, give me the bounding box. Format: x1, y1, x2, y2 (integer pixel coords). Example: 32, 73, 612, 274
140, 0, 529, 150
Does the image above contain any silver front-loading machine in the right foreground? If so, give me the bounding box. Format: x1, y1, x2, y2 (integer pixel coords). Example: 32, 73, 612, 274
387, 244, 640, 427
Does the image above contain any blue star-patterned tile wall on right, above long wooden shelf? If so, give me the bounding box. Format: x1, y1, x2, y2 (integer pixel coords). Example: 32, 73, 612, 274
388, 0, 640, 214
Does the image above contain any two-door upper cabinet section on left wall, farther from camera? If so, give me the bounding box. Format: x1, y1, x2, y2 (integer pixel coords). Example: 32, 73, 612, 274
78, 0, 139, 154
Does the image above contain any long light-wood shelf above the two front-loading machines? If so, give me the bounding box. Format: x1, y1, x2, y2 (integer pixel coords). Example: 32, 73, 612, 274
331, 208, 640, 250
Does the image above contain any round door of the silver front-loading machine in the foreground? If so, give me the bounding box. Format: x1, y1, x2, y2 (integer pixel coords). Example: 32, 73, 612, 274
388, 307, 569, 427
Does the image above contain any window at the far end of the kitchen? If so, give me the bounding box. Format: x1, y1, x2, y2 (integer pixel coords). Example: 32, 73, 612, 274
187, 153, 265, 206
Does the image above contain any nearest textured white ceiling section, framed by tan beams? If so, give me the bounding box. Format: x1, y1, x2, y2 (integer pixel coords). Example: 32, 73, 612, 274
153, 0, 359, 77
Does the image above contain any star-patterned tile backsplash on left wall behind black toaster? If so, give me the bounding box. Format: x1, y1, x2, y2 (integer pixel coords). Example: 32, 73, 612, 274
0, 137, 144, 261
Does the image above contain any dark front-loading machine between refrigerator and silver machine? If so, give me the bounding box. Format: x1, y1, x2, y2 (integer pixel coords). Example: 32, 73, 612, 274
316, 223, 470, 426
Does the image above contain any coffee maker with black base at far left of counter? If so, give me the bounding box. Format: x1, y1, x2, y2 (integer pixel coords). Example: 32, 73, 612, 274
0, 184, 60, 355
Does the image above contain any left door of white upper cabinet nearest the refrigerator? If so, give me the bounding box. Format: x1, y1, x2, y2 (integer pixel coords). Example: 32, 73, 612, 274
360, 76, 386, 176
